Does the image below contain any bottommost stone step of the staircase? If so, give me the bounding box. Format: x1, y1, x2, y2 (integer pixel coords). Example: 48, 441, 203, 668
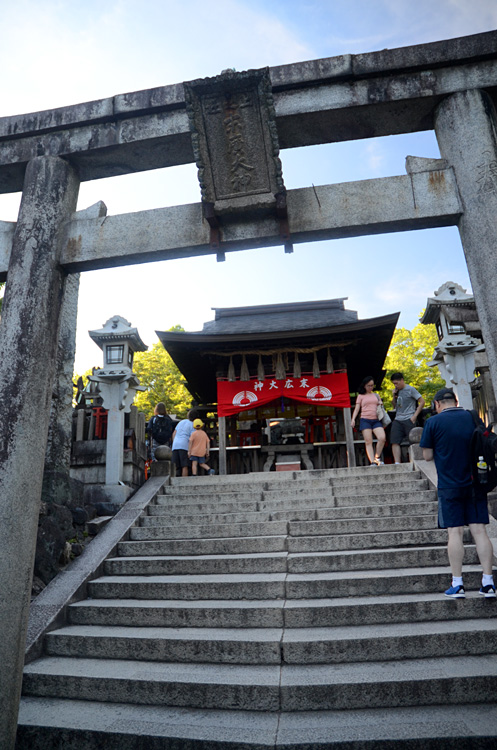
16, 697, 495, 750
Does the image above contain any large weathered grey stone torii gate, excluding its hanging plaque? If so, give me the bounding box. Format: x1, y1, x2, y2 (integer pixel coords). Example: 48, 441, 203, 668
0, 32, 497, 749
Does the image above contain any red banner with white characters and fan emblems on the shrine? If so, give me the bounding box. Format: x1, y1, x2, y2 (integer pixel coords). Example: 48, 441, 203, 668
217, 372, 350, 417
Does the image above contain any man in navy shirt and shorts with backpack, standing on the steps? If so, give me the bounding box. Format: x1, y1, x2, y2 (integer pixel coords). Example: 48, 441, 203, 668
420, 388, 495, 599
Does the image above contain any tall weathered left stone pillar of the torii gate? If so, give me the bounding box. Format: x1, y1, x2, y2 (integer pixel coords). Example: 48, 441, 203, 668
0, 156, 79, 750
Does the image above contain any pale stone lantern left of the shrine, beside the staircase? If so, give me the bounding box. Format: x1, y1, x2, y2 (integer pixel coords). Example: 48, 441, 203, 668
89, 315, 148, 504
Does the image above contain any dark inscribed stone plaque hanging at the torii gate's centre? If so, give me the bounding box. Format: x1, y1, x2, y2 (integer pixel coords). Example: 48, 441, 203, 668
185, 68, 284, 214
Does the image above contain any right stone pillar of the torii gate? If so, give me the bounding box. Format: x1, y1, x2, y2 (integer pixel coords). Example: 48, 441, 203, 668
435, 90, 497, 400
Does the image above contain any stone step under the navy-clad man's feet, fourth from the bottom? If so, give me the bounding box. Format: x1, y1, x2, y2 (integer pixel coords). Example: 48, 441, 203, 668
69, 592, 497, 628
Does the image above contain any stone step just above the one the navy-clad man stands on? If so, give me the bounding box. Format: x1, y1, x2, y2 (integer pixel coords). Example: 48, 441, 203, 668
89, 566, 481, 600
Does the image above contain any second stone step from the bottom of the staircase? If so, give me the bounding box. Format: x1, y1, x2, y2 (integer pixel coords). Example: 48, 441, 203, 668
23, 654, 497, 711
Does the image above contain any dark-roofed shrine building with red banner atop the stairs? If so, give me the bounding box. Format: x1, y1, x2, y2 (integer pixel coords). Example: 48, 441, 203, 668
157, 297, 399, 474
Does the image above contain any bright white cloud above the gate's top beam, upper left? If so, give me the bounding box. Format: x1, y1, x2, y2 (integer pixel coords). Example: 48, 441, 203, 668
0, 0, 315, 115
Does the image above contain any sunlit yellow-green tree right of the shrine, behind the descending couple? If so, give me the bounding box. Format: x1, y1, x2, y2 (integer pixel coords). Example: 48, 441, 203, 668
379, 323, 445, 409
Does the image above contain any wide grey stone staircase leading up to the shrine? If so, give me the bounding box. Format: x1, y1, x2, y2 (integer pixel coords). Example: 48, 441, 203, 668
17, 465, 497, 750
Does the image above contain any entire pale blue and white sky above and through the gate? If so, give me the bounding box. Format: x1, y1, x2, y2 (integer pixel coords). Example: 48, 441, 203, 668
0, 0, 497, 372
